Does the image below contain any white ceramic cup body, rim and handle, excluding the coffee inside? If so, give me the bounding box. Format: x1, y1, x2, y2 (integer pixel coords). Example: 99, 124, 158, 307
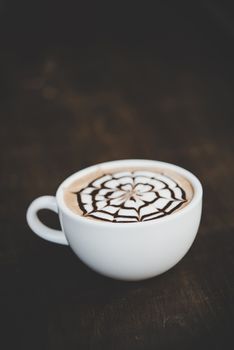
27, 159, 202, 281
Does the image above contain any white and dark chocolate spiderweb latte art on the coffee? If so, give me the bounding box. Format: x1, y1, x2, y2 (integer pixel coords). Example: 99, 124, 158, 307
73, 170, 190, 223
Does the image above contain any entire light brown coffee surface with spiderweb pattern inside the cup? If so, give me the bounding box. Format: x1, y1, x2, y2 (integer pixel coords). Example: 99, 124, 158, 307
64, 167, 193, 223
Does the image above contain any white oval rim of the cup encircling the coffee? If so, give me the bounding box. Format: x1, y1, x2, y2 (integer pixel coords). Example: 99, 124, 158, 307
56, 159, 203, 228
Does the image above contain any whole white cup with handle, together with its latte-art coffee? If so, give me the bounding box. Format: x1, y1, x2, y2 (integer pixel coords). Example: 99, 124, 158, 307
26, 159, 202, 281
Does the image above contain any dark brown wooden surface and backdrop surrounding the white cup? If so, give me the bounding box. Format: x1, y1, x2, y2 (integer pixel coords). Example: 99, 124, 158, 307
0, 0, 234, 350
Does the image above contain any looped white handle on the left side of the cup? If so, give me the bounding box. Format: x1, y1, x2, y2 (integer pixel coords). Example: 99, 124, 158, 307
26, 196, 68, 245
